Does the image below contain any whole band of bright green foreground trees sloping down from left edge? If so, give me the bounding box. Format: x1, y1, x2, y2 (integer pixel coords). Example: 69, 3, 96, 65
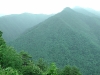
0, 31, 82, 75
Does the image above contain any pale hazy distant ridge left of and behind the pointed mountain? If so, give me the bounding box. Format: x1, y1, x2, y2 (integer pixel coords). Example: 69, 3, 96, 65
0, 13, 51, 42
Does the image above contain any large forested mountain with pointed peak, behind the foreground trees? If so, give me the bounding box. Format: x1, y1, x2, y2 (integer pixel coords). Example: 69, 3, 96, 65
10, 7, 100, 75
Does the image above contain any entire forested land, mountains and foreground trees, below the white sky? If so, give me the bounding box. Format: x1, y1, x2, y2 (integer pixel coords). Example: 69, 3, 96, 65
0, 7, 100, 75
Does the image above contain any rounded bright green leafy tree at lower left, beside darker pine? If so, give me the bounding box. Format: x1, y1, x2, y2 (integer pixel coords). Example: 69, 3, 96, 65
1, 46, 22, 69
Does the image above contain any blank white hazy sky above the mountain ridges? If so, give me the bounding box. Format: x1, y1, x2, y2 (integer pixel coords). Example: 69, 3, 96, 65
0, 0, 100, 14
